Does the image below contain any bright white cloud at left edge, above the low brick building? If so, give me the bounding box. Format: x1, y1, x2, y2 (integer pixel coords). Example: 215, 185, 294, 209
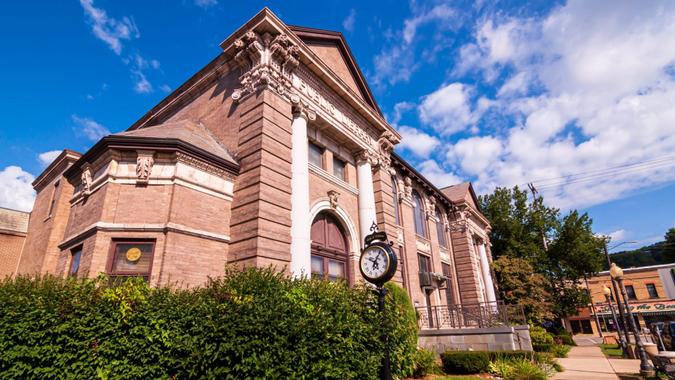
0, 166, 35, 211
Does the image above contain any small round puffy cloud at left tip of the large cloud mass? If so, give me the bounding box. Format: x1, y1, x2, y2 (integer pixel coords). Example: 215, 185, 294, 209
418, 83, 474, 135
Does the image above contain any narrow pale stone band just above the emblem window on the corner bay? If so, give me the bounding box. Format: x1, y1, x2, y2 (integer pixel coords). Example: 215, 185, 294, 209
58, 222, 230, 250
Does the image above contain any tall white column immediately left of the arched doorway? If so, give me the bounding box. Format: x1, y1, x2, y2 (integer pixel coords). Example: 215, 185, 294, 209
291, 99, 315, 277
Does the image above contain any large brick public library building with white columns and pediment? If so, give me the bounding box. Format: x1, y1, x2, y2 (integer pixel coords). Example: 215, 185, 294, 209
13, 9, 524, 350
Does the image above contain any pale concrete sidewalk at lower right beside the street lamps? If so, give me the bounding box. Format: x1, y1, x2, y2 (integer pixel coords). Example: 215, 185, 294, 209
553, 346, 640, 380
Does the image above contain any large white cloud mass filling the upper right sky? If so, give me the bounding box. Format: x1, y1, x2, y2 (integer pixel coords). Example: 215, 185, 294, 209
440, 0, 675, 209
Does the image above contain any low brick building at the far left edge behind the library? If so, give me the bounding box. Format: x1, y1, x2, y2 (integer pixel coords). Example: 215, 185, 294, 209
0, 207, 29, 279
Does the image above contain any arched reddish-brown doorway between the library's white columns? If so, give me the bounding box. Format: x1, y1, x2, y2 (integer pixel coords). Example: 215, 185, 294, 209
311, 211, 349, 281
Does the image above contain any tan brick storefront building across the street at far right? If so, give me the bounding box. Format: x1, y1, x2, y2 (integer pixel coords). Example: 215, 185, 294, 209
568, 264, 675, 335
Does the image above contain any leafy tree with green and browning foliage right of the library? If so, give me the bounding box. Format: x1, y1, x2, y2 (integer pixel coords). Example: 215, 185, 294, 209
480, 187, 603, 321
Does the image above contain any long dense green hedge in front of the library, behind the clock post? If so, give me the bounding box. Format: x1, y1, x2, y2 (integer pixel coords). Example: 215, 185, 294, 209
0, 269, 416, 379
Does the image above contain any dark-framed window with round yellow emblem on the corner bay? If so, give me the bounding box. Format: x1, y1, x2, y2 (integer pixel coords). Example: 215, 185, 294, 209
110, 240, 155, 281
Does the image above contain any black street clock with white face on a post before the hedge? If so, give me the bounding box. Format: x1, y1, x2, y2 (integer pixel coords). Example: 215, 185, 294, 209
359, 223, 398, 380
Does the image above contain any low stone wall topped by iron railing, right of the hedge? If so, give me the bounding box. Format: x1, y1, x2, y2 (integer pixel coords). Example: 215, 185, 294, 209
418, 326, 532, 354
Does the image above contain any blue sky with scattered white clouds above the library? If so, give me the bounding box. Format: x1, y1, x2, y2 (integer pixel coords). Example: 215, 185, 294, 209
0, 0, 675, 251
